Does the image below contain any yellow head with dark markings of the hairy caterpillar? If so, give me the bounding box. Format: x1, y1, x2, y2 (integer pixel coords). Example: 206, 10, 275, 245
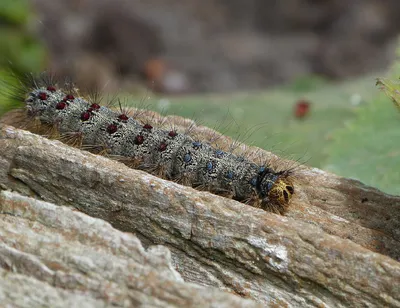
259, 168, 294, 213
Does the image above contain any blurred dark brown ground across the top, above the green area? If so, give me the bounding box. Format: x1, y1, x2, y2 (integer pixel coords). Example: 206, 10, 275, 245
22, 0, 400, 93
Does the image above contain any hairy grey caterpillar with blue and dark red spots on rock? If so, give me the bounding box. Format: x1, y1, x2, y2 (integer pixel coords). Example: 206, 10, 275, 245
0, 74, 294, 214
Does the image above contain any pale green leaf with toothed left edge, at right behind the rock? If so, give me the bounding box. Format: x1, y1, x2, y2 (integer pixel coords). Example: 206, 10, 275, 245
324, 95, 400, 194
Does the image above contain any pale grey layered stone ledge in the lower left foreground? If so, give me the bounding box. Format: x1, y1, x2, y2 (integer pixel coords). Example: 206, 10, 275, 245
0, 191, 257, 307
